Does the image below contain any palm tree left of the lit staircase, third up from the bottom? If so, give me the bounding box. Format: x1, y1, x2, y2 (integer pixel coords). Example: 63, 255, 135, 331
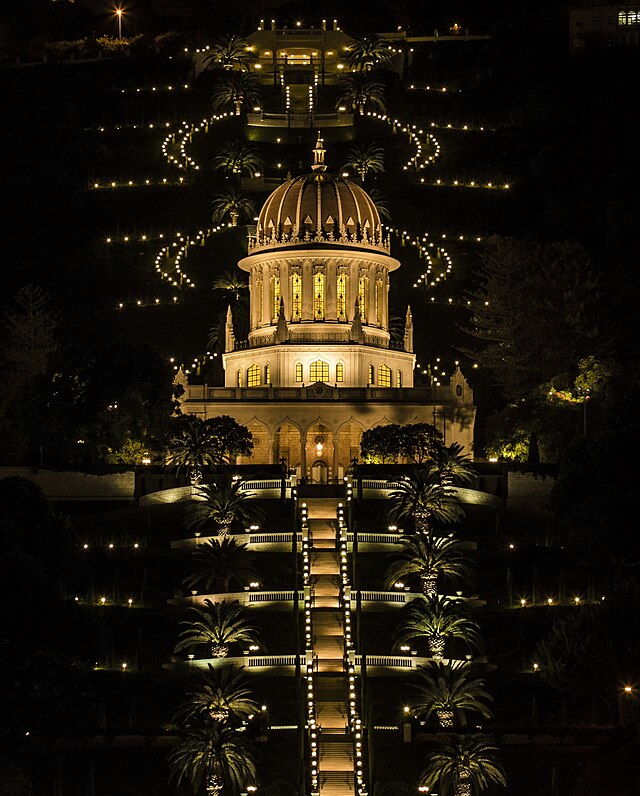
174, 600, 257, 658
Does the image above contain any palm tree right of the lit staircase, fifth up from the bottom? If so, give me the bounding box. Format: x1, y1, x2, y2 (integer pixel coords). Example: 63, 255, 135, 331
388, 467, 464, 533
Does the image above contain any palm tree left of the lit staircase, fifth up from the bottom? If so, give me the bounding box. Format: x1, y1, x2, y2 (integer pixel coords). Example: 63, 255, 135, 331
186, 475, 262, 536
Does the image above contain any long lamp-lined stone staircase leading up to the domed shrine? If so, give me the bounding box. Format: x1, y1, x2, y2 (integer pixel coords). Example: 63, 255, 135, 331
309, 505, 355, 796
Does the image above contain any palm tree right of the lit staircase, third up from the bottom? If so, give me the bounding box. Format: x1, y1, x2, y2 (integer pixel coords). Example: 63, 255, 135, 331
395, 596, 481, 660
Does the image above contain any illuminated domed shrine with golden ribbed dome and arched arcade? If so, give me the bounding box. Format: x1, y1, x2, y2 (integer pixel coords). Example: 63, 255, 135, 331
183, 140, 475, 482
